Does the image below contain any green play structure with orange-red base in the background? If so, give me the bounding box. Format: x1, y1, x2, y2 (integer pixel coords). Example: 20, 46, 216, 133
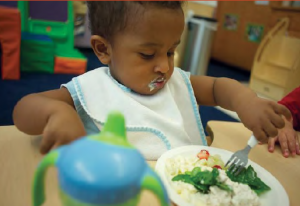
18, 1, 87, 74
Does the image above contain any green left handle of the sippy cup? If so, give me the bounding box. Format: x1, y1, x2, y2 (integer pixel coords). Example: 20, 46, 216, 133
32, 150, 59, 206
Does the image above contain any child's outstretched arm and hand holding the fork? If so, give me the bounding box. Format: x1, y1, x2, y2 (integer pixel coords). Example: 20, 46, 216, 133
190, 76, 291, 142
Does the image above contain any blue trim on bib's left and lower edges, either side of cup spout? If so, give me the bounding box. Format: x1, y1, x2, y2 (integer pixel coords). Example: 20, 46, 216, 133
73, 78, 171, 150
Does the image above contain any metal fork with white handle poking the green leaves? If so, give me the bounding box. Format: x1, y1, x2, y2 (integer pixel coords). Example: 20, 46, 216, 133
225, 135, 258, 175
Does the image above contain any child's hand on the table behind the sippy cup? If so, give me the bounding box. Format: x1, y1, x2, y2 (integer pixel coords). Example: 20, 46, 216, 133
40, 108, 86, 154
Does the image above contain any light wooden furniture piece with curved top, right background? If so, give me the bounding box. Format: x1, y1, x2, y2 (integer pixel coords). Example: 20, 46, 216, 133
250, 18, 300, 101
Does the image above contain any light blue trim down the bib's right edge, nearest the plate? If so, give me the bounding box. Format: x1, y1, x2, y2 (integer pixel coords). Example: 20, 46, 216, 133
178, 69, 207, 146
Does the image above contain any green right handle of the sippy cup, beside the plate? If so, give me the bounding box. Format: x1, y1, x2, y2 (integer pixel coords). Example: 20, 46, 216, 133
141, 166, 170, 206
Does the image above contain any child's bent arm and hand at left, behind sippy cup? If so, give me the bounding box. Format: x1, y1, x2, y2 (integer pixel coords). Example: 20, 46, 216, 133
13, 88, 86, 153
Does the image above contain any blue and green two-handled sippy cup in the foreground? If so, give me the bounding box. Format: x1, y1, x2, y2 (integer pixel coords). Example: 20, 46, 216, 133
33, 112, 170, 206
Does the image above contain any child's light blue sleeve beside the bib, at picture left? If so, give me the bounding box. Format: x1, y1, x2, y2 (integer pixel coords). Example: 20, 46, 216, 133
61, 81, 100, 135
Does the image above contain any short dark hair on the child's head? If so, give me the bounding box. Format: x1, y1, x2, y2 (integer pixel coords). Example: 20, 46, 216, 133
87, 1, 183, 42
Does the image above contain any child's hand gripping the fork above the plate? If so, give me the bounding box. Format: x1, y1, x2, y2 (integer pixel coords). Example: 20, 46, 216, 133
236, 97, 291, 143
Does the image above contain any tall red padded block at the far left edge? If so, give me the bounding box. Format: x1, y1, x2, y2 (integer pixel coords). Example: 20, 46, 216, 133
0, 6, 21, 79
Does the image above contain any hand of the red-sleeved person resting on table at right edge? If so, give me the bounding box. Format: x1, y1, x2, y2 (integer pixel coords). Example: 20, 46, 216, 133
268, 118, 300, 157
